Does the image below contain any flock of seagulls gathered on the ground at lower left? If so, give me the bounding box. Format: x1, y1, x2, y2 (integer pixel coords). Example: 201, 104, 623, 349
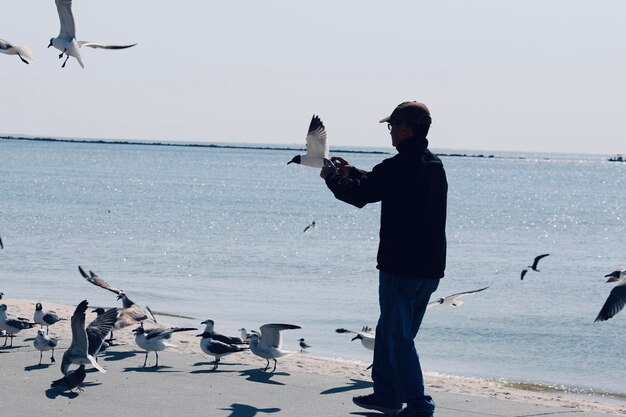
0, 266, 310, 391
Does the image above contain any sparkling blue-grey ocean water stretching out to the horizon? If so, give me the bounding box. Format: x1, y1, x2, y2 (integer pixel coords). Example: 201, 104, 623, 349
0, 140, 626, 393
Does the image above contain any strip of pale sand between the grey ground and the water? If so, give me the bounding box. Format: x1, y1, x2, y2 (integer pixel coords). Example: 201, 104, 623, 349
0, 298, 626, 416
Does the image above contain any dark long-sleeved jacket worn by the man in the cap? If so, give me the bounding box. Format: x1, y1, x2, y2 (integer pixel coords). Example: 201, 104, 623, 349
326, 137, 448, 278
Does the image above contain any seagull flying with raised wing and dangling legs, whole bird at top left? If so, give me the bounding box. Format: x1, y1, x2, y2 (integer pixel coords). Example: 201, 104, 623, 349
48, 0, 137, 68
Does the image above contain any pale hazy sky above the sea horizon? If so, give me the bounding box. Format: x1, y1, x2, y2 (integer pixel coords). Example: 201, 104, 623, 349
0, 0, 626, 156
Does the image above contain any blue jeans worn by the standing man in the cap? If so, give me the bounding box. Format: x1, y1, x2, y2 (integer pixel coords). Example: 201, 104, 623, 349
372, 271, 439, 412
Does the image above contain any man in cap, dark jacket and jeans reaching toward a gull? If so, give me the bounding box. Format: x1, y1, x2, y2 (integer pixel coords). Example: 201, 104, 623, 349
320, 101, 448, 417
